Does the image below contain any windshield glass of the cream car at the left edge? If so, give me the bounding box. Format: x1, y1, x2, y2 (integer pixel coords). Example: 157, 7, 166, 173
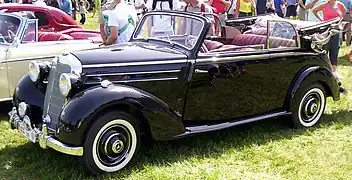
0, 14, 21, 44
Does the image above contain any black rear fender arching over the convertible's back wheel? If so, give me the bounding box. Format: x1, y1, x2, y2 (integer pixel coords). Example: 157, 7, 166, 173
285, 66, 340, 111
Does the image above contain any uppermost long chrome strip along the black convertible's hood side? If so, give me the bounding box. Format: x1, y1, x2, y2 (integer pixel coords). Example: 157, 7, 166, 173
82, 59, 187, 68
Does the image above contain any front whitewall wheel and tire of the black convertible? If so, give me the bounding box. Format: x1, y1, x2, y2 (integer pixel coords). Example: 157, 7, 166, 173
82, 111, 140, 175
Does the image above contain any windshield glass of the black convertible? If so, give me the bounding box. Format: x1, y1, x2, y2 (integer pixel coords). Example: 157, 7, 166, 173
133, 13, 204, 49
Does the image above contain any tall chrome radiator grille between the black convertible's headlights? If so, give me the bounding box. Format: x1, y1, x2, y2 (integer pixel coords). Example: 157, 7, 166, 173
43, 60, 71, 130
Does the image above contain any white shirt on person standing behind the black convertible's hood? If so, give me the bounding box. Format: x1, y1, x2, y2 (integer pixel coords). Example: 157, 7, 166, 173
103, 1, 137, 44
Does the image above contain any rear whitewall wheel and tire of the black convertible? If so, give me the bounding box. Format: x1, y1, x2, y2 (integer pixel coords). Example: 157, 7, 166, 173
291, 83, 326, 128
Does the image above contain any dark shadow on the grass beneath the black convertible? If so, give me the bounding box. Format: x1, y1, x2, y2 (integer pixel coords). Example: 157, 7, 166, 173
0, 111, 352, 179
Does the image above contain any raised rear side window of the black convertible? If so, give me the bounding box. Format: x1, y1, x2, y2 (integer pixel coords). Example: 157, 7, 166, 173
268, 21, 298, 49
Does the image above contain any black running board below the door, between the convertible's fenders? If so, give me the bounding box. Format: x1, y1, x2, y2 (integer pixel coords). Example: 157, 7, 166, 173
172, 112, 291, 139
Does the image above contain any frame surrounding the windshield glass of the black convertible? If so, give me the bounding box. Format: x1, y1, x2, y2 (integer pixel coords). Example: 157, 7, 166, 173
130, 10, 210, 51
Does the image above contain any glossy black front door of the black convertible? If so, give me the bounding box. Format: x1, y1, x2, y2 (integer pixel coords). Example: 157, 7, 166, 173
184, 49, 271, 124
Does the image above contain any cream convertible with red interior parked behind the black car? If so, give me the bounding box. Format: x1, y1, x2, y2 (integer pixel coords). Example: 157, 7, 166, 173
0, 13, 98, 102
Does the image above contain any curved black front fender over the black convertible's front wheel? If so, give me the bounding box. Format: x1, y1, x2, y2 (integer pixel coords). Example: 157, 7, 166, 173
56, 85, 185, 145
